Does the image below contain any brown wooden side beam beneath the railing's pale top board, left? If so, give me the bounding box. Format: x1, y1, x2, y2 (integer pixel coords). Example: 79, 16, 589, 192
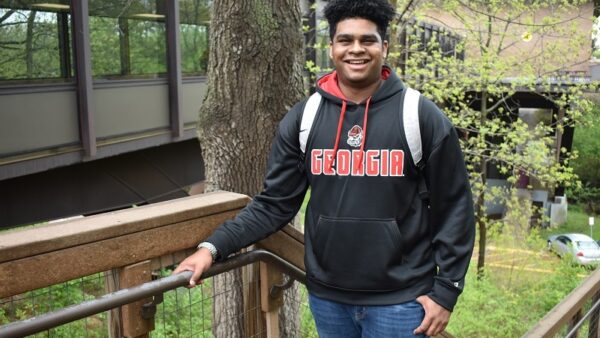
0, 210, 239, 298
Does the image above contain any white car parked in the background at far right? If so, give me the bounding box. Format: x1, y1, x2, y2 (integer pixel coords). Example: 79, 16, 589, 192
548, 234, 600, 265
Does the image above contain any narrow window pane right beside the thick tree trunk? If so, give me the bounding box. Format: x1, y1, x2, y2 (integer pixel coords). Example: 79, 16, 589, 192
179, 0, 211, 75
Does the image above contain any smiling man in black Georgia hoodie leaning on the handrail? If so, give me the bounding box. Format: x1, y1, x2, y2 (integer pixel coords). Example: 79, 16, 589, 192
174, 0, 474, 337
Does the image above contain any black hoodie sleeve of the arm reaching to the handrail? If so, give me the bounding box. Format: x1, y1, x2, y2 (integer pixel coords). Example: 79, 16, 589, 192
206, 103, 308, 260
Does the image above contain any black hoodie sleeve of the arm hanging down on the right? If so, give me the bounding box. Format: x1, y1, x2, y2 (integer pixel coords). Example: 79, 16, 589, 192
421, 99, 475, 311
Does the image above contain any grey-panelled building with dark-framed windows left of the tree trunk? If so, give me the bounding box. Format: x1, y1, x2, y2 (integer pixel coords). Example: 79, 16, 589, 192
0, 0, 211, 227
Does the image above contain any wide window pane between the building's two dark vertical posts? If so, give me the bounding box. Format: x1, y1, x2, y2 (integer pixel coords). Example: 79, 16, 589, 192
90, 0, 167, 78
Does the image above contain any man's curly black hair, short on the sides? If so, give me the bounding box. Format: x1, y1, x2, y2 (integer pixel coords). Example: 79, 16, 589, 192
324, 0, 396, 40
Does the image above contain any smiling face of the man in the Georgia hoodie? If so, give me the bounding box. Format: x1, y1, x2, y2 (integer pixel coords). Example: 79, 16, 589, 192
329, 19, 388, 88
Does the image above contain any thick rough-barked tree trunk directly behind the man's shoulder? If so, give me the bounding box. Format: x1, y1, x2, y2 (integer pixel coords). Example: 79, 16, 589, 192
198, 0, 304, 338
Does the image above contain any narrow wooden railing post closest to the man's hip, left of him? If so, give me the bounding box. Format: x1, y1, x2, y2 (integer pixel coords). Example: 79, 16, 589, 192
260, 262, 283, 338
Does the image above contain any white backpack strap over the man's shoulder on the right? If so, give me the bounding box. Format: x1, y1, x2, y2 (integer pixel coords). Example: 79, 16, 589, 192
402, 87, 423, 167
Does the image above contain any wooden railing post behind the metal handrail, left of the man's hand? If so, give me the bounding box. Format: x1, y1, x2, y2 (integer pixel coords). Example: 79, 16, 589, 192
119, 260, 154, 338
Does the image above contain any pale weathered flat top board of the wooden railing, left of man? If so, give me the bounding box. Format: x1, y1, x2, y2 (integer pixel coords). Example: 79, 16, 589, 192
0, 192, 250, 263
